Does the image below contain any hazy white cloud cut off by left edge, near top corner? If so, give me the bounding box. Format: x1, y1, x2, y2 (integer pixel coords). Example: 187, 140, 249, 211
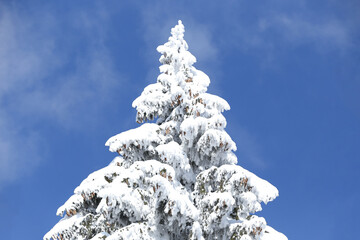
0, 8, 53, 96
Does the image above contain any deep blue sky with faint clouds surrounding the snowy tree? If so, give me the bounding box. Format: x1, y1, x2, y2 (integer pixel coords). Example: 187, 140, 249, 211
0, 0, 360, 240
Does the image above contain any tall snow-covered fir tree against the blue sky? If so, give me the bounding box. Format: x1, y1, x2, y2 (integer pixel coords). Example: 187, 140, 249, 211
44, 21, 287, 240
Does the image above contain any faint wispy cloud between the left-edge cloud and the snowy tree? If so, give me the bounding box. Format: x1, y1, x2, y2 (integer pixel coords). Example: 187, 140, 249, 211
9, 45, 120, 128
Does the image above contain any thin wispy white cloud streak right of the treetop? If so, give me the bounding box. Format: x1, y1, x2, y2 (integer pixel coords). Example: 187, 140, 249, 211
223, 4, 354, 54
